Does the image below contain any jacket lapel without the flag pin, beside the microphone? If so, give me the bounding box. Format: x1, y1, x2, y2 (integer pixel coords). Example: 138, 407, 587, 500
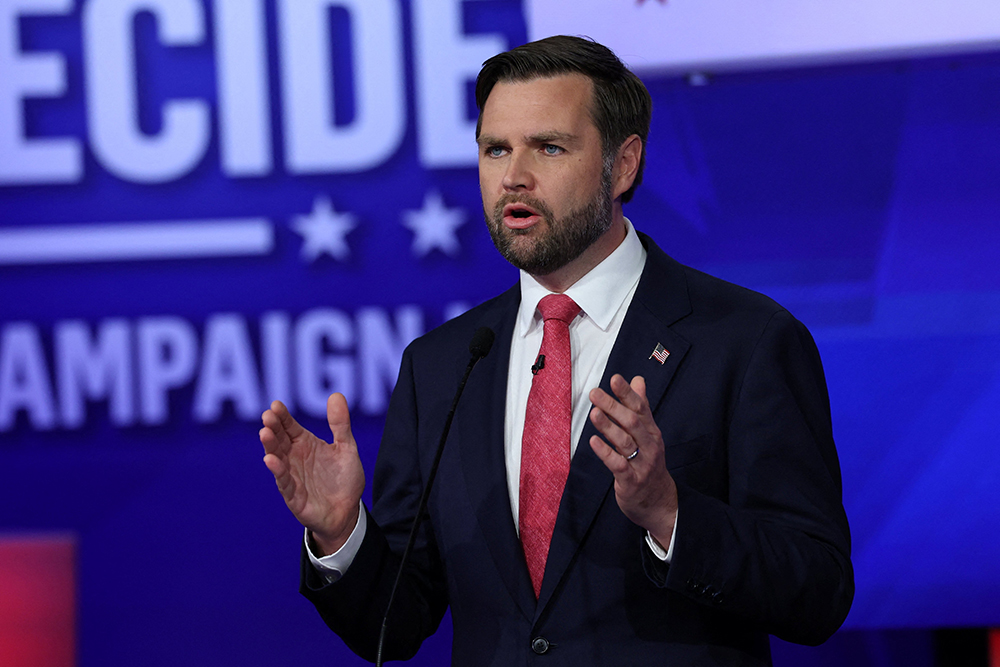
460, 286, 535, 619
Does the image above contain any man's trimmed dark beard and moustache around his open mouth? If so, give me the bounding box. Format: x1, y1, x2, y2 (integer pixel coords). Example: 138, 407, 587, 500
484, 170, 612, 276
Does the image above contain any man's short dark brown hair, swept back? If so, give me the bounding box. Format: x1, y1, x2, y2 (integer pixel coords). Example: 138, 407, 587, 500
476, 35, 653, 203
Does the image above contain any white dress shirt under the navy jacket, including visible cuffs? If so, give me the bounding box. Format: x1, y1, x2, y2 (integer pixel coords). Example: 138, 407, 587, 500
306, 220, 676, 582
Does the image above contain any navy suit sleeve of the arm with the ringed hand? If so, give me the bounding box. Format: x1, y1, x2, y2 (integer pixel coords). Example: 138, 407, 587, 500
644, 310, 854, 645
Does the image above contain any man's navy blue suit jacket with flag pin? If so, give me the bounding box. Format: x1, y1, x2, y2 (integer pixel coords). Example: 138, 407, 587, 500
301, 235, 854, 667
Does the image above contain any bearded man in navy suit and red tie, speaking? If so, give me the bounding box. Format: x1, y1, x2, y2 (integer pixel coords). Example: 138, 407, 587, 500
260, 37, 853, 666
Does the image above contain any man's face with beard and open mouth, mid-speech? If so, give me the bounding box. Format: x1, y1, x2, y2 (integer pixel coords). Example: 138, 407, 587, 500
479, 74, 612, 276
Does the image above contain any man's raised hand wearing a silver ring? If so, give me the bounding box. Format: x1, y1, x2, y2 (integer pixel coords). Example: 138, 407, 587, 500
590, 375, 677, 549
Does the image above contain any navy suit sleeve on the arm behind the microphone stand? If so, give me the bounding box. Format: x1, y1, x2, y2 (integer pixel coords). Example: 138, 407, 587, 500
299, 348, 447, 662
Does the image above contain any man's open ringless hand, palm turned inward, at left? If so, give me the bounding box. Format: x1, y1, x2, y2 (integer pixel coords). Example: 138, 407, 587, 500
259, 394, 365, 556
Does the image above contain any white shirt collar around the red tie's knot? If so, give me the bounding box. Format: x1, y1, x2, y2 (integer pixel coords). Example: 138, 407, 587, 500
517, 218, 646, 337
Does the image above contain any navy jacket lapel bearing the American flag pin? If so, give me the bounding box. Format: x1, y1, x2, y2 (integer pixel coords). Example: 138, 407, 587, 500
536, 234, 691, 618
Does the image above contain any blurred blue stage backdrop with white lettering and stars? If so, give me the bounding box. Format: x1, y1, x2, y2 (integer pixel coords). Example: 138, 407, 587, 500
0, 0, 1000, 667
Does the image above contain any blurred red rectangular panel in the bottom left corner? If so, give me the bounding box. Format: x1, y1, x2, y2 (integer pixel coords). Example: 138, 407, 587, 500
0, 536, 76, 667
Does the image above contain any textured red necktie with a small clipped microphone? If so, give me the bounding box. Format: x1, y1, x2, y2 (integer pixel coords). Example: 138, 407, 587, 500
518, 294, 580, 597
